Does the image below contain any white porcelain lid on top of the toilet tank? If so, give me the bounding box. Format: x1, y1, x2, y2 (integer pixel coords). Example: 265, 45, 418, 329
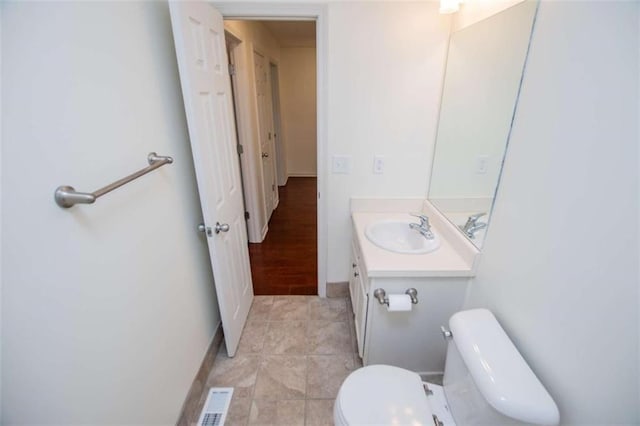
449, 309, 560, 425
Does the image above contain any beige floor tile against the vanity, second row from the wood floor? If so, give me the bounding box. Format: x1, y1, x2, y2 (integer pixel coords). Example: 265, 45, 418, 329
307, 321, 353, 355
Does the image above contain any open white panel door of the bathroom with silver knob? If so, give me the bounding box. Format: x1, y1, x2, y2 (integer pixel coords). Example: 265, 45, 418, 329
170, 2, 253, 356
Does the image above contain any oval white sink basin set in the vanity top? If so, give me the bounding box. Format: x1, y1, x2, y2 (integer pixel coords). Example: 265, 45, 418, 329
365, 220, 440, 254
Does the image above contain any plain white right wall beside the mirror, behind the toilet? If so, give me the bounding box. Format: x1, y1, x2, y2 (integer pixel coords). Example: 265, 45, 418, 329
466, 2, 640, 425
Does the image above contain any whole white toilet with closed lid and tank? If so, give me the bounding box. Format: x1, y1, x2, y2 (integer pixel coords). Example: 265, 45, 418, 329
333, 309, 560, 426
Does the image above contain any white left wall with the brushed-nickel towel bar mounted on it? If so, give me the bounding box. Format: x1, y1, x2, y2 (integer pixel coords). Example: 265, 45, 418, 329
0, 2, 220, 425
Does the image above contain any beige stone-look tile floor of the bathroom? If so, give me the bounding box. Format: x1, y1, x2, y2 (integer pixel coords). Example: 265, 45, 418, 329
191, 296, 362, 426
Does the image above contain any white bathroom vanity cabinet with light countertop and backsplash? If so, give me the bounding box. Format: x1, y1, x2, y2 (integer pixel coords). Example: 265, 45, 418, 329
349, 202, 479, 374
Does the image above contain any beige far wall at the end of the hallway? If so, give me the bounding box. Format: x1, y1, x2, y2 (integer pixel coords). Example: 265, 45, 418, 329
279, 47, 317, 176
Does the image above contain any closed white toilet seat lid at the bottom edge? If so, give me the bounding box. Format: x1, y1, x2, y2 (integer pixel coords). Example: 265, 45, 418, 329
334, 365, 433, 425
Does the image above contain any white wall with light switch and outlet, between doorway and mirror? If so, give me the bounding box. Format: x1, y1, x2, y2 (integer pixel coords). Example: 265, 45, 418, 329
326, 2, 450, 282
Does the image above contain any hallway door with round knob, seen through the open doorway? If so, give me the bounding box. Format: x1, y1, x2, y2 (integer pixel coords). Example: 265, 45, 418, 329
253, 51, 276, 222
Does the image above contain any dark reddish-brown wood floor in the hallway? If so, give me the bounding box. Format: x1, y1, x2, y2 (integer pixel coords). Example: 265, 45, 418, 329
249, 177, 318, 295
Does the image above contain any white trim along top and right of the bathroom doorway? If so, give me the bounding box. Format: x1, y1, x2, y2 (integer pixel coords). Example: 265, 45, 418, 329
211, 1, 328, 297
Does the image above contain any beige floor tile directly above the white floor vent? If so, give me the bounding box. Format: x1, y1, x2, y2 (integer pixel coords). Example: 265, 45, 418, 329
206, 353, 260, 398
